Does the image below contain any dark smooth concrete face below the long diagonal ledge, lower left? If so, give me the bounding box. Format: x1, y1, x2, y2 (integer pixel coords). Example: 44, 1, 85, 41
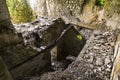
11, 51, 51, 80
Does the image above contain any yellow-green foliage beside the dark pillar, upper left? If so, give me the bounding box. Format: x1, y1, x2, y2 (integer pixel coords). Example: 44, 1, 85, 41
7, 0, 33, 23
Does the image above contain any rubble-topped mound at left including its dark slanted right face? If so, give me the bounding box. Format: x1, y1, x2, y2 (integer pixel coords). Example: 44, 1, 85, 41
14, 17, 65, 52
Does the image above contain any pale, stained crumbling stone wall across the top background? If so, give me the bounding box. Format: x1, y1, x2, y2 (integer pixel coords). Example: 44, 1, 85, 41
31, 0, 120, 30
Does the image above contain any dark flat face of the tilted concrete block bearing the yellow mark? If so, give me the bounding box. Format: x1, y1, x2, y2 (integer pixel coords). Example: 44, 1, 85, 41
58, 26, 86, 60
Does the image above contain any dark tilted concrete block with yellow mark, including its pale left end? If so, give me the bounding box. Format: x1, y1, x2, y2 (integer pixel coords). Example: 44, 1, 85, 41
51, 26, 86, 63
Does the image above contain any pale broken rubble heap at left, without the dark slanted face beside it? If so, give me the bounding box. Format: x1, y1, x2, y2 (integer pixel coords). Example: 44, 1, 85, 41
14, 18, 55, 47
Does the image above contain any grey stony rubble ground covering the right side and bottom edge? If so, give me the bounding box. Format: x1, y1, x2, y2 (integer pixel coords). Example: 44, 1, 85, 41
40, 31, 117, 80
